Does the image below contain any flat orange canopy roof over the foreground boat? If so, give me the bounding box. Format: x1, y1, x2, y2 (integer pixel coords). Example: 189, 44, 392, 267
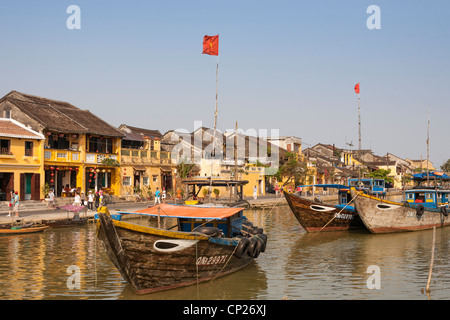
120, 204, 243, 219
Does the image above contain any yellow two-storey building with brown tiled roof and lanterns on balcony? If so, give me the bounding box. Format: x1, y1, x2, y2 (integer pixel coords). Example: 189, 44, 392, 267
0, 91, 123, 196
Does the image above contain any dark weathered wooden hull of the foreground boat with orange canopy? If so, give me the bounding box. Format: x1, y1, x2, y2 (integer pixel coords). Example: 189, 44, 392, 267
97, 212, 253, 294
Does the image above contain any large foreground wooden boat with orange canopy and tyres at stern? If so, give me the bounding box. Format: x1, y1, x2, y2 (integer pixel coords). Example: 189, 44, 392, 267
97, 204, 267, 294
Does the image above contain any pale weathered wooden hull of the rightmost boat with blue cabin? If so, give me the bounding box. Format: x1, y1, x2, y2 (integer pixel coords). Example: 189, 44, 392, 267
351, 190, 450, 233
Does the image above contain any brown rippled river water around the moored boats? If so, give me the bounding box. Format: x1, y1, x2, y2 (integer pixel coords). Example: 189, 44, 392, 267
0, 206, 450, 300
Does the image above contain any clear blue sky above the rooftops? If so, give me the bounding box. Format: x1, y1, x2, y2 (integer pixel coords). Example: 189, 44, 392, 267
0, 0, 450, 165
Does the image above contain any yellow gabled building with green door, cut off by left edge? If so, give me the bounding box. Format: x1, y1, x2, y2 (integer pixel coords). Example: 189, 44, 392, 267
0, 117, 44, 201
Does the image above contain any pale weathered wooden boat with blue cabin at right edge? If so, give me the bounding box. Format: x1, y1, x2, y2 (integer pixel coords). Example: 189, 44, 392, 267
351, 187, 450, 233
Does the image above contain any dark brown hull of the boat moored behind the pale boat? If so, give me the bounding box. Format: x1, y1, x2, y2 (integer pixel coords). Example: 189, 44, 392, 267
284, 192, 365, 232
